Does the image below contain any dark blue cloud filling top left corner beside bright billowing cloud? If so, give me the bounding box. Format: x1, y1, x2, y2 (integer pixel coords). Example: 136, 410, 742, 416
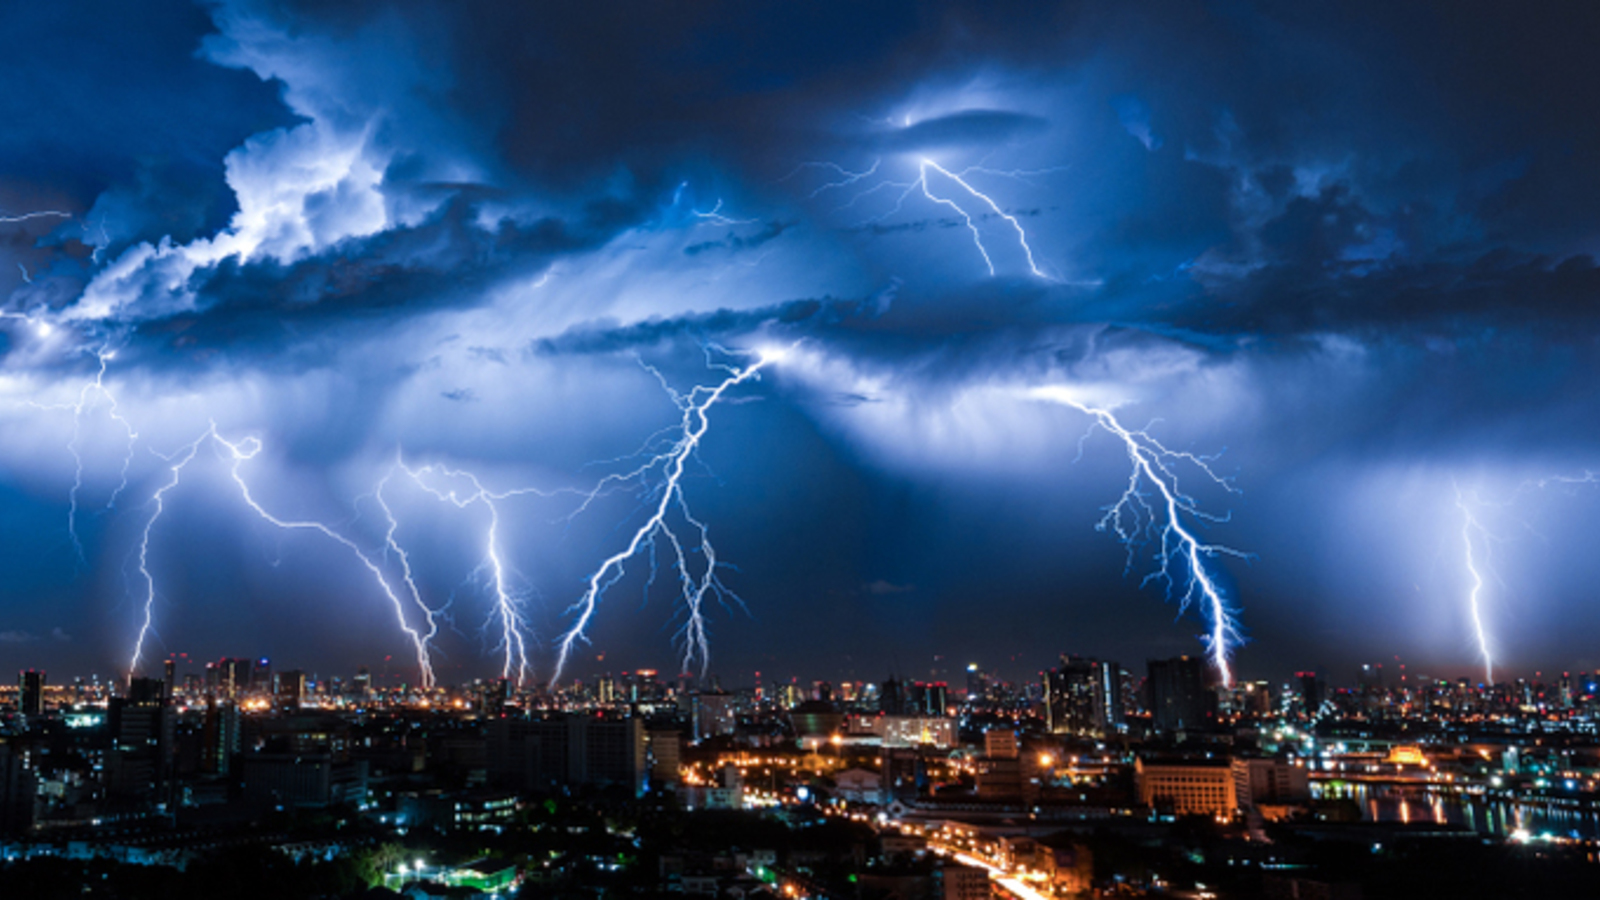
0, 0, 293, 245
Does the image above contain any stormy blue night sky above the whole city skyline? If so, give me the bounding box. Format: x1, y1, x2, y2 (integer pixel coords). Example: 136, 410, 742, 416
0, 0, 1600, 684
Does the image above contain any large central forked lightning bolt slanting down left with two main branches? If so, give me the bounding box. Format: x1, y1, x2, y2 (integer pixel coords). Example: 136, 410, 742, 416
550, 351, 784, 684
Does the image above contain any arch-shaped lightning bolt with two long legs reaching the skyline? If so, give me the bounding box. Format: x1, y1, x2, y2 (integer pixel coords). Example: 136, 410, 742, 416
128, 423, 435, 689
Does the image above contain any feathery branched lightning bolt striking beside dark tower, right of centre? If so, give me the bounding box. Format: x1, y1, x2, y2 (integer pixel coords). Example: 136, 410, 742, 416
1032, 386, 1250, 685
